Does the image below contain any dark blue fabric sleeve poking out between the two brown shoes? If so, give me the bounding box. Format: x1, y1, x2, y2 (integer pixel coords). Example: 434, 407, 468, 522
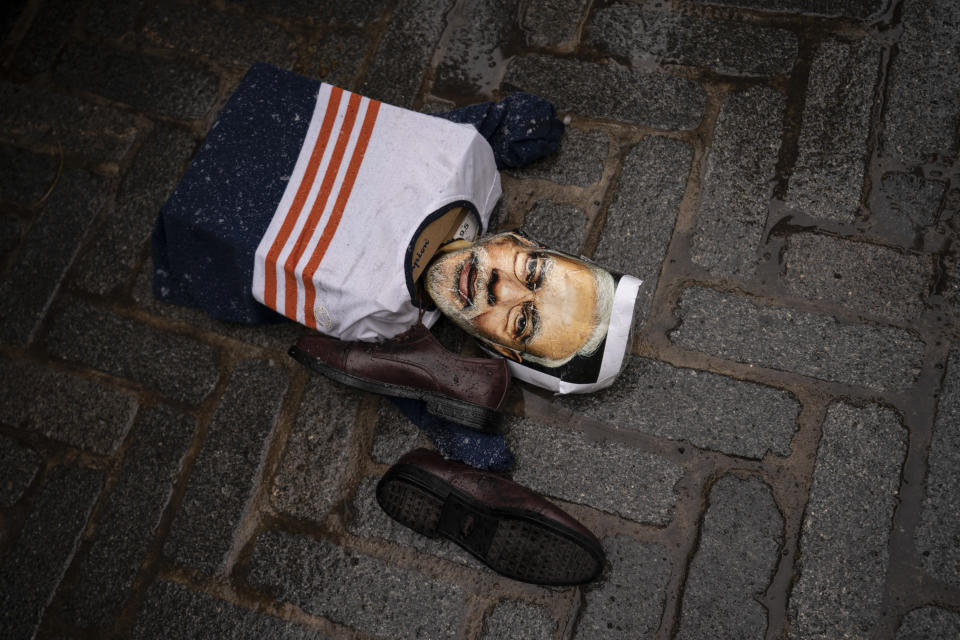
390, 398, 514, 471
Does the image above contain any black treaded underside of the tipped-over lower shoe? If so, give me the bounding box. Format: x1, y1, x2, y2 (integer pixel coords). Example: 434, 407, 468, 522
377, 464, 605, 586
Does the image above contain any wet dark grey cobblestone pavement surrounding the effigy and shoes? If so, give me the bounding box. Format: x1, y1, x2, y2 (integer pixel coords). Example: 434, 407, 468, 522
0, 0, 960, 640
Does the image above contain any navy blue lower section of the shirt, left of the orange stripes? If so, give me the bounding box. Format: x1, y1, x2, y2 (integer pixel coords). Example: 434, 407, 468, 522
152, 64, 320, 324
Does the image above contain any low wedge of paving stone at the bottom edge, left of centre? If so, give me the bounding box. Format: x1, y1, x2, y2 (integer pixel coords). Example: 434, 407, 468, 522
133, 582, 327, 640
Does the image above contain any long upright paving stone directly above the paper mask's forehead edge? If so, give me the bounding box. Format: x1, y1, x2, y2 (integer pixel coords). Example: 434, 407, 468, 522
593, 136, 693, 326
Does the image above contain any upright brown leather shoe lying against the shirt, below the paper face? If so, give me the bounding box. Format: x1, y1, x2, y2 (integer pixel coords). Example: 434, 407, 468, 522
290, 323, 510, 433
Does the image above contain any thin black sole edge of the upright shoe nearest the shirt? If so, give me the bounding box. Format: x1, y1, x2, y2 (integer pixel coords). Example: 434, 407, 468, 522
288, 346, 503, 435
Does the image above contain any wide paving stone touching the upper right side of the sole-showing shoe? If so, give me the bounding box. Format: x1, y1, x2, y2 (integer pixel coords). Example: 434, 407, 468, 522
504, 418, 682, 525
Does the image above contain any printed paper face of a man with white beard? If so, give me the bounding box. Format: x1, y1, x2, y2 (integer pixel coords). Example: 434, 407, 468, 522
427, 233, 612, 363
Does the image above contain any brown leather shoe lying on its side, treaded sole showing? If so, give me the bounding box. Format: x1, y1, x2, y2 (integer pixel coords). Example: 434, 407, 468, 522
377, 449, 605, 585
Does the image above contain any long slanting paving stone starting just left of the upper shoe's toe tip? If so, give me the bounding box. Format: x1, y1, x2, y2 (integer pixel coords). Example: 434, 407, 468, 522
164, 360, 287, 574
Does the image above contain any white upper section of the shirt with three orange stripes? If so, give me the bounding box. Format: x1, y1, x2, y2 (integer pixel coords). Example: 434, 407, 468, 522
253, 84, 501, 340
